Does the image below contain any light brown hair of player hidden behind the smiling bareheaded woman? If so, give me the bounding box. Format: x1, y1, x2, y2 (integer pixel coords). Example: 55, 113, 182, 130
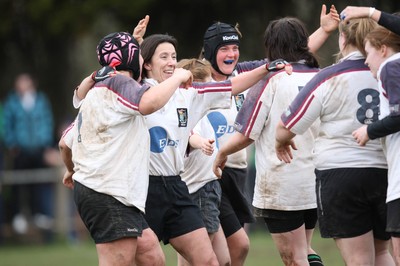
176, 58, 211, 82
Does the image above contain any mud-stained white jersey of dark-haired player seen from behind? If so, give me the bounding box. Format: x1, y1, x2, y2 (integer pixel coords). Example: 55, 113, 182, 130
235, 63, 319, 211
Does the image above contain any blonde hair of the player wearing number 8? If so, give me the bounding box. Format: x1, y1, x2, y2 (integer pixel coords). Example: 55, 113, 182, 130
339, 18, 378, 56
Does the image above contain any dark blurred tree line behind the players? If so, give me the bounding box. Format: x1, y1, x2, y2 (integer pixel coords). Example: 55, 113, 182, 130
0, 0, 400, 140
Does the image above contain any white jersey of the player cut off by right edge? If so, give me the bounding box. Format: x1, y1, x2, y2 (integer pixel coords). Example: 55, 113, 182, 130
377, 53, 400, 202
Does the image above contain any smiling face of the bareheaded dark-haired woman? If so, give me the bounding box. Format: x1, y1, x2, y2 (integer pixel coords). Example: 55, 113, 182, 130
144, 42, 177, 82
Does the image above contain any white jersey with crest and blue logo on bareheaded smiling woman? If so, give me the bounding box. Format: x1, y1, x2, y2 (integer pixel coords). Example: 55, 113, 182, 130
144, 79, 232, 176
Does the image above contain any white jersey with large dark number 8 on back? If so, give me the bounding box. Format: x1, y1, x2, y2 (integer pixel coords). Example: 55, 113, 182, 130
282, 52, 387, 170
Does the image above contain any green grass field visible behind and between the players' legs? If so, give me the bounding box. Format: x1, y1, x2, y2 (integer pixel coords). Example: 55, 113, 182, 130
0, 230, 343, 266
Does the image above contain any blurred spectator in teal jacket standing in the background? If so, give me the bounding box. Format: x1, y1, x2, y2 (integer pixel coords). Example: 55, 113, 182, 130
3, 73, 56, 241
